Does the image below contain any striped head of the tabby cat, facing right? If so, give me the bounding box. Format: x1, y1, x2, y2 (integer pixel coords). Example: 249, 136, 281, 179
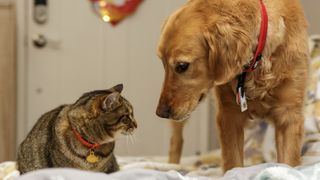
68, 84, 137, 144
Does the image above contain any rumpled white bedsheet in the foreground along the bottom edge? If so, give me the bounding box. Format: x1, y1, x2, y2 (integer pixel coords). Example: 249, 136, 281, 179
14, 163, 320, 180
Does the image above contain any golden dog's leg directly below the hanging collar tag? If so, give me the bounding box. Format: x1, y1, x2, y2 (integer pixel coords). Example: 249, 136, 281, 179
217, 106, 246, 172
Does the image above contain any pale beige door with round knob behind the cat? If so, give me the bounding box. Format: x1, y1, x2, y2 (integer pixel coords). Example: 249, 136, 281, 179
19, 0, 209, 156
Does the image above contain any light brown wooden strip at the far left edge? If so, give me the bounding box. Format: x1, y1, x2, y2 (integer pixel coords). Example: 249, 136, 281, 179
0, 1, 16, 162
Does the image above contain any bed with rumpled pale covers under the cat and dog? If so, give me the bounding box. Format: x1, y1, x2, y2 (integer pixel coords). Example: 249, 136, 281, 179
0, 158, 320, 180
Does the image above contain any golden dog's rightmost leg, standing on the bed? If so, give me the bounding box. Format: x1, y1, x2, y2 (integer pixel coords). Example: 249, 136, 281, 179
275, 108, 304, 166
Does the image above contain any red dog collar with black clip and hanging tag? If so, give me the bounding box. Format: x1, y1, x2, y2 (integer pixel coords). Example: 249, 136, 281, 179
236, 0, 268, 112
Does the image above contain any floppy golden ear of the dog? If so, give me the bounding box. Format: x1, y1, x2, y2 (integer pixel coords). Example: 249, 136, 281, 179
204, 20, 252, 85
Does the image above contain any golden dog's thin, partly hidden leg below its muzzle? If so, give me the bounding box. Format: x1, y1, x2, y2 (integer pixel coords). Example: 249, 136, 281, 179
169, 120, 184, 164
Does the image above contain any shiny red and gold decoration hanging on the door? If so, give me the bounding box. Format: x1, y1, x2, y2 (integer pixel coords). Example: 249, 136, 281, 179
90, 0, 143, 26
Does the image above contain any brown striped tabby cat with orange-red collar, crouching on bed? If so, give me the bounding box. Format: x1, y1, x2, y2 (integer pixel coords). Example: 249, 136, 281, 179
17, 84, 137, 173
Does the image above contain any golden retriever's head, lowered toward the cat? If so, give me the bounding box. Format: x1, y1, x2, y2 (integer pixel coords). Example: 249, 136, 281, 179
156, 1, 251, 120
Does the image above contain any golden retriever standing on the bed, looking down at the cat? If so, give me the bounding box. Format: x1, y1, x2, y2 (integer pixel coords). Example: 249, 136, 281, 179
156, 0, 308, 171
